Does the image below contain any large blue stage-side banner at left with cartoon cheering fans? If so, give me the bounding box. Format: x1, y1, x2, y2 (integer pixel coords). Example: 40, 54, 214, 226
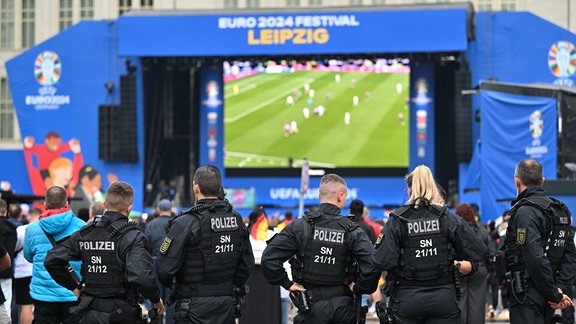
6, 21, 143, 209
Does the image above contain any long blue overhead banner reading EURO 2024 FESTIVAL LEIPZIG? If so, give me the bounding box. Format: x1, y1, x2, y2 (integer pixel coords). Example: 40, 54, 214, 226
118, 8, 467, 56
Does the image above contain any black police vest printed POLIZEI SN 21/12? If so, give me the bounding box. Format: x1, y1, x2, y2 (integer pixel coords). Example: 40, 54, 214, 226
78, 220, 138, 297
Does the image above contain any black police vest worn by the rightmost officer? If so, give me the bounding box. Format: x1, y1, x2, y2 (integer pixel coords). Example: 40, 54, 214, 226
505, 196, 571, 272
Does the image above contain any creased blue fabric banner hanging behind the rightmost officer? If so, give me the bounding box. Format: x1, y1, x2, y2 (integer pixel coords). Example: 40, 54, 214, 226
480, 90, 557, 219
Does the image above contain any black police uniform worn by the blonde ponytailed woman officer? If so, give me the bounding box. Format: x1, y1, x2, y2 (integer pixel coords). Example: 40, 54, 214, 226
374, 205, 488, 324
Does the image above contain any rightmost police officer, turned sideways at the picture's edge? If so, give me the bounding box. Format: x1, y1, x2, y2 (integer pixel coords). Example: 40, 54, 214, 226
504, 159, 576, 324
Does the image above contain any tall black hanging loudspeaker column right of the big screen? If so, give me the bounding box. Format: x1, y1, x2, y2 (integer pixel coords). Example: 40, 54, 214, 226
454, 69, 473, 162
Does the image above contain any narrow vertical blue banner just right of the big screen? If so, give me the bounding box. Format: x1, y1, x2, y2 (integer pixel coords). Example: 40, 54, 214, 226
409, 61, 436, 172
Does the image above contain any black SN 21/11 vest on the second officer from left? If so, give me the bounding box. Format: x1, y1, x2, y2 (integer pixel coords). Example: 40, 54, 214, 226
176, 201, 247, 297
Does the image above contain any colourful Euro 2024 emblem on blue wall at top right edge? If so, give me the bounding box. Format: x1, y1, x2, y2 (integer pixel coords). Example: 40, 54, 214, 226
548, 41, 576, 87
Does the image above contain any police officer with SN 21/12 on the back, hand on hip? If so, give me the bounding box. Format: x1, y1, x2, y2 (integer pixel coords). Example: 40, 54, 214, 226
44, 182, 164, 324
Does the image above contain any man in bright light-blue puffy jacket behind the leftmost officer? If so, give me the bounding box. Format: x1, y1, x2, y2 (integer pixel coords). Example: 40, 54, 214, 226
24, 186, 86, 324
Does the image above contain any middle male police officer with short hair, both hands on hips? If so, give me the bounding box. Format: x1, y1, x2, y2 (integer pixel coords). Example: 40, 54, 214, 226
262, 174, 380, 323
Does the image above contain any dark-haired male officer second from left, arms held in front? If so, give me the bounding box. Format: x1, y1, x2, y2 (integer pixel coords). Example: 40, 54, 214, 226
156, 165, 254, 324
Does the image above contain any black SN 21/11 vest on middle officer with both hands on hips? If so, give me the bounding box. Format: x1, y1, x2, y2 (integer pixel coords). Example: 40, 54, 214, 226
290, 212, 358, 286
